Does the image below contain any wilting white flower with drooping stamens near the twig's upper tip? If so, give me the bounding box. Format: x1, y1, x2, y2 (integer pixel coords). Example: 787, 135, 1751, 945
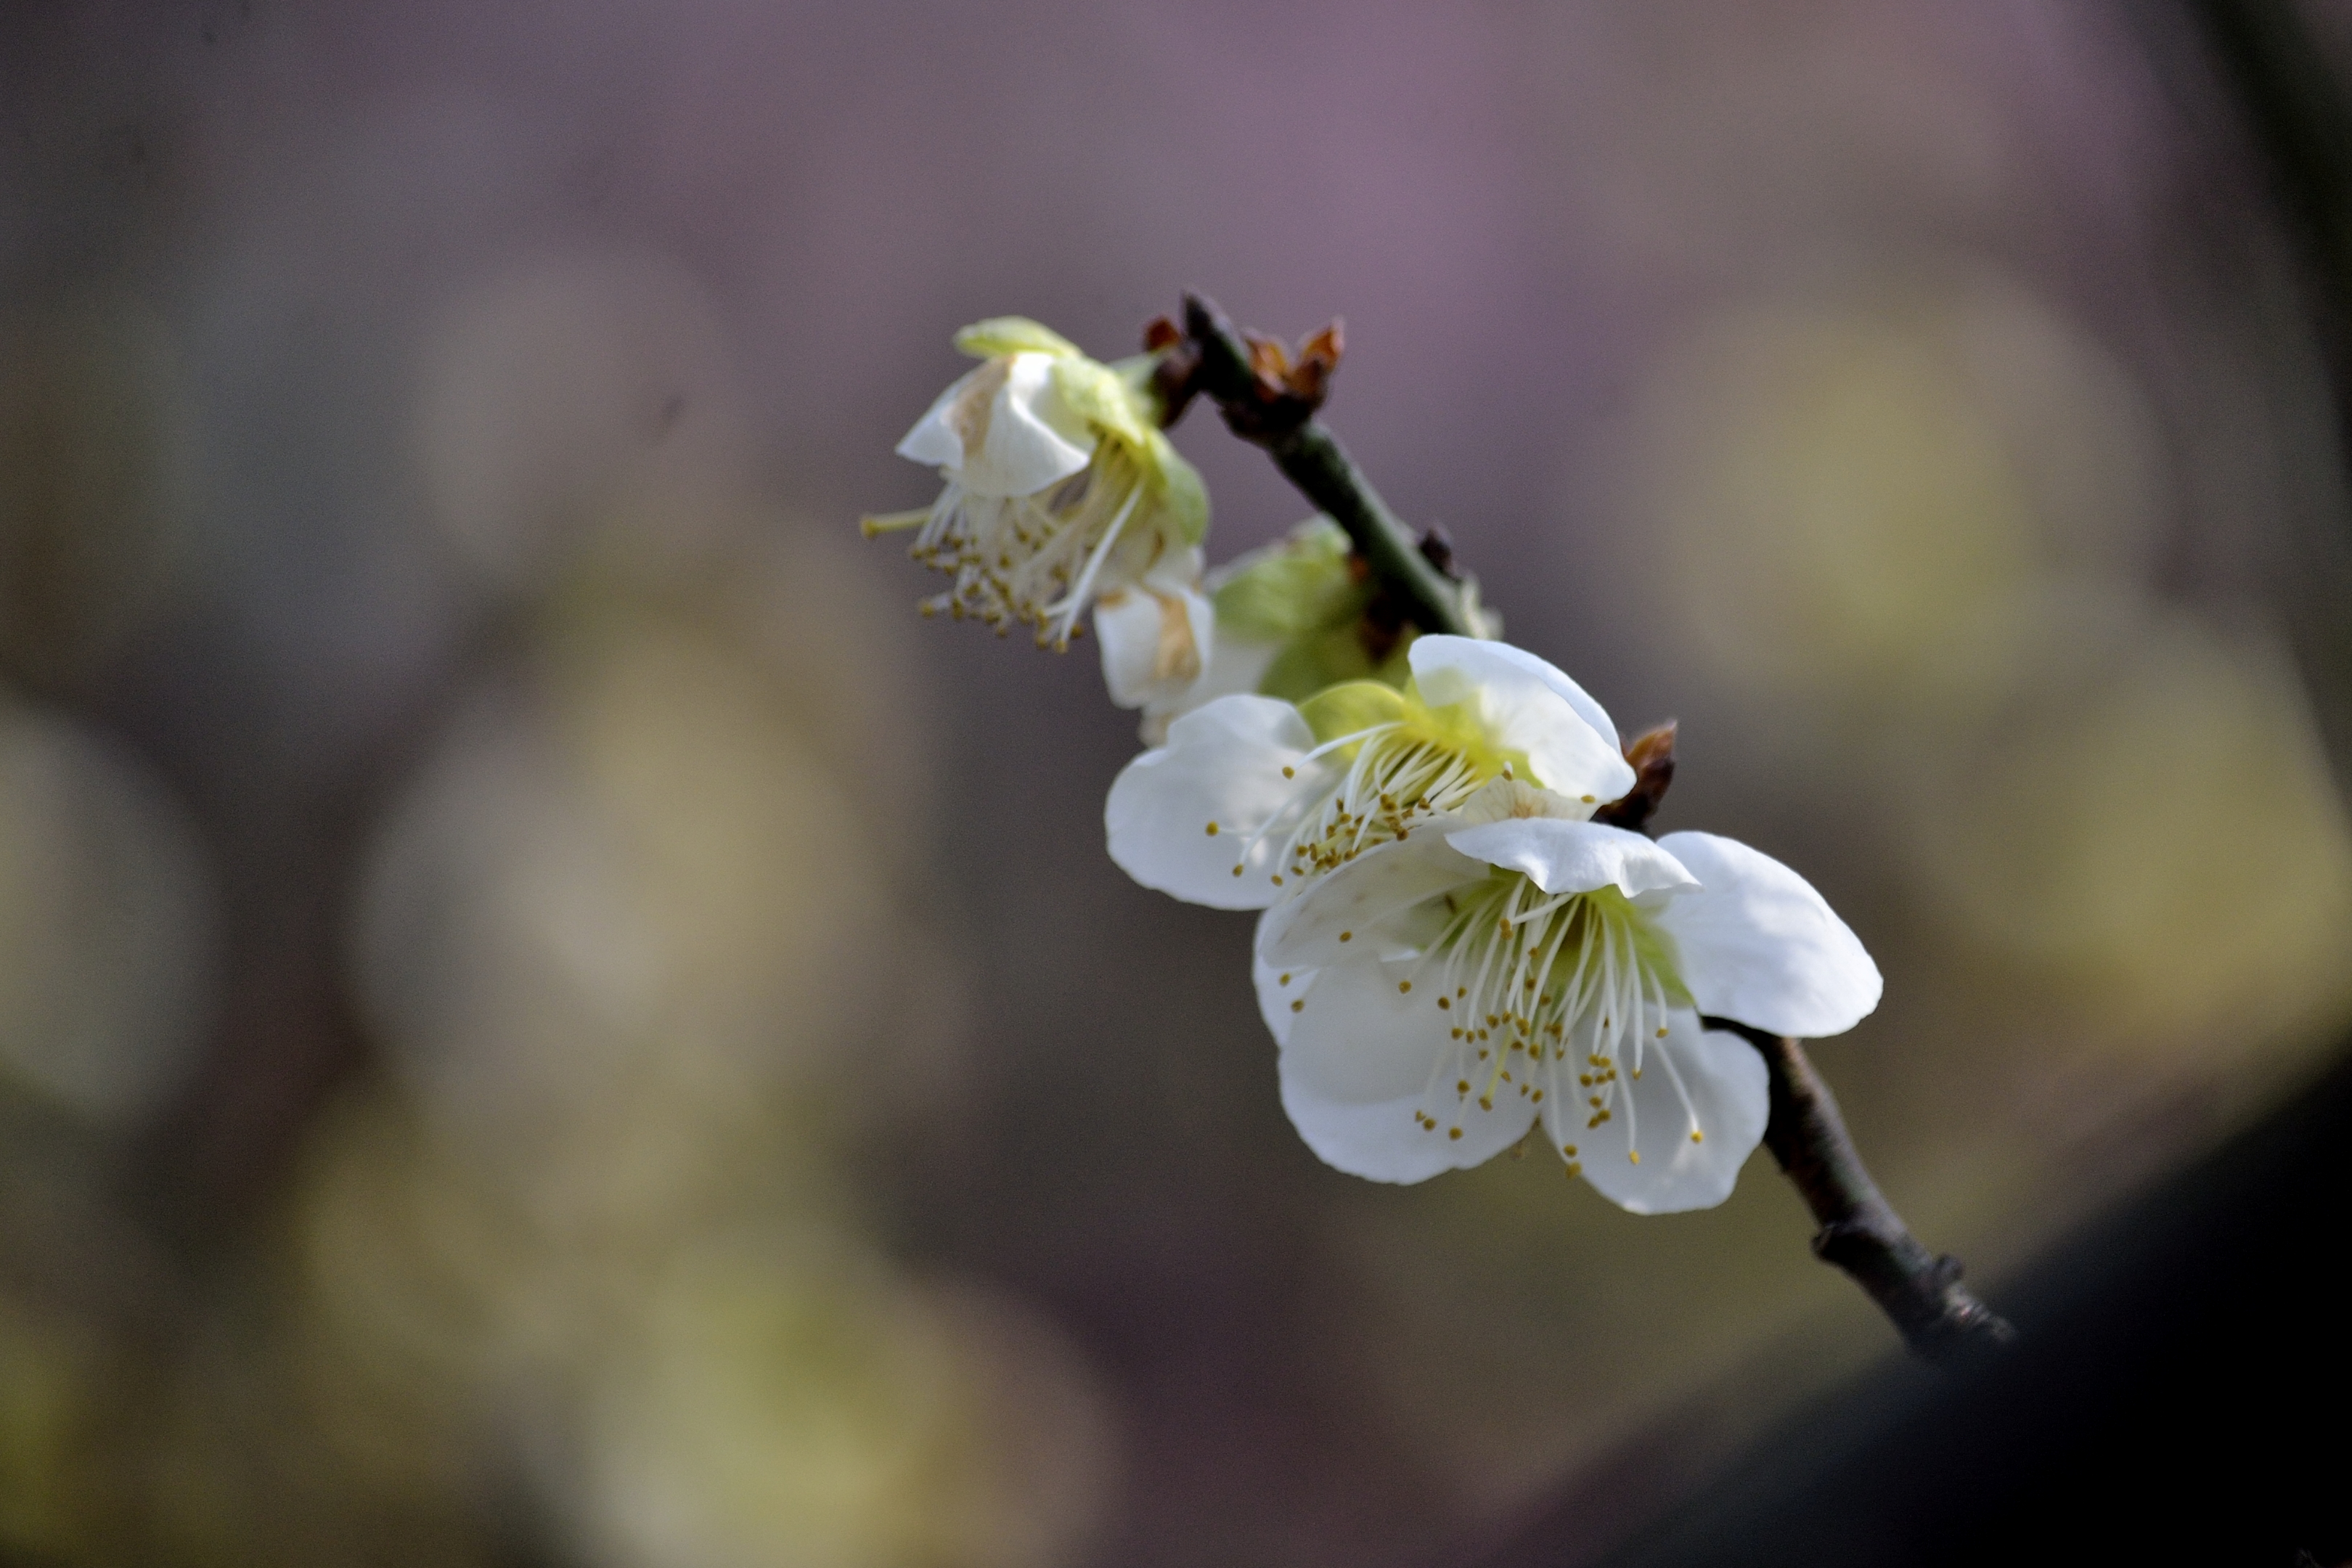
863, 315, 1212, 663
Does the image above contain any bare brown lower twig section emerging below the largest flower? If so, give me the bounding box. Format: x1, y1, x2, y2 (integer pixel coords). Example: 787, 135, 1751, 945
1703, 1018, 2018, 1363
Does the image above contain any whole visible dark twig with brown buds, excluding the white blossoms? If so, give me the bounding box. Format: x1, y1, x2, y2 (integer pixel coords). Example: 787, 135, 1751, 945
1185, 294, 2016, 1363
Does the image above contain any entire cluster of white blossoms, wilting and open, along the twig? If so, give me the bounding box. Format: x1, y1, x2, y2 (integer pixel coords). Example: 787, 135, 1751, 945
875, 322, 1879, 1213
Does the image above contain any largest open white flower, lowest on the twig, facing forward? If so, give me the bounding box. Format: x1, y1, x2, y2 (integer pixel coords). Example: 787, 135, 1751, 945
1258, 780, 1879, 1213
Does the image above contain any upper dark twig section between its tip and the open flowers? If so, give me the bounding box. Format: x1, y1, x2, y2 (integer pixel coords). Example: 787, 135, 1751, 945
1183, 294, 1477, 637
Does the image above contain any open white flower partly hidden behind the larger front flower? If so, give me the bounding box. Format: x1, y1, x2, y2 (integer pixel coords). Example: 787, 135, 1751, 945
1103, 637, 1635, 910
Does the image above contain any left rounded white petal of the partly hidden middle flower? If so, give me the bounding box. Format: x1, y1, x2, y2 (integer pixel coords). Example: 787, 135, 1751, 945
1103, 696, 1331, 910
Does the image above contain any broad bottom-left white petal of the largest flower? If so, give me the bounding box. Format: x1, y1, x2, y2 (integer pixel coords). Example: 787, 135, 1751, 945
1282, 959, 1536, 1183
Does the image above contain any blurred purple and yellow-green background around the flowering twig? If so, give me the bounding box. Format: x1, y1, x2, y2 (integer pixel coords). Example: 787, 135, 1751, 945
0, 0, 2352, 1568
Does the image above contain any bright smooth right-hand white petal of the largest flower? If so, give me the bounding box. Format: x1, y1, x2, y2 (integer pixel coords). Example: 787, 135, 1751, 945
1651, 832, 1884, 1039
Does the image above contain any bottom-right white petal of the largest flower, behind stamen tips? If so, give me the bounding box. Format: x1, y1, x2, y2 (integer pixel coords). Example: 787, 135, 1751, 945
1543, 1011, 1771, 1213
